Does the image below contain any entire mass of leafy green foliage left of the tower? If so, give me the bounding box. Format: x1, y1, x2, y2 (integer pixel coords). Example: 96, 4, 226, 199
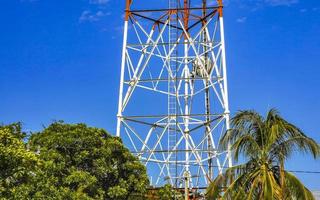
0, 122, 149, 200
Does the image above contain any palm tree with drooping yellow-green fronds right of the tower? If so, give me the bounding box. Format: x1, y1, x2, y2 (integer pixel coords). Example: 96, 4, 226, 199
207, 109, 320, 200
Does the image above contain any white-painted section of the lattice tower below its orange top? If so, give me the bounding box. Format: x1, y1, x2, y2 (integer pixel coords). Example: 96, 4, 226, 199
116, 1, 232, 187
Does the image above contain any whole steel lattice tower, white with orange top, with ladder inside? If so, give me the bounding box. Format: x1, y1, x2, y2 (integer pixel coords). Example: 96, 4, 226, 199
117, 0, 232, 189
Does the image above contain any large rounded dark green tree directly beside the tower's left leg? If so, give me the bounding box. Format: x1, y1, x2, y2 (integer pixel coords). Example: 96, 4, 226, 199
25, 122, 149, 200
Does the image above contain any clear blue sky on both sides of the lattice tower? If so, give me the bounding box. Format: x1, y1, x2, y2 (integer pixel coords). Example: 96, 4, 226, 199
0, 0, 320, 190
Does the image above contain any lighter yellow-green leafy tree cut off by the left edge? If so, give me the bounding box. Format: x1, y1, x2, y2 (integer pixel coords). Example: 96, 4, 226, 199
0, 123, 40, 199
